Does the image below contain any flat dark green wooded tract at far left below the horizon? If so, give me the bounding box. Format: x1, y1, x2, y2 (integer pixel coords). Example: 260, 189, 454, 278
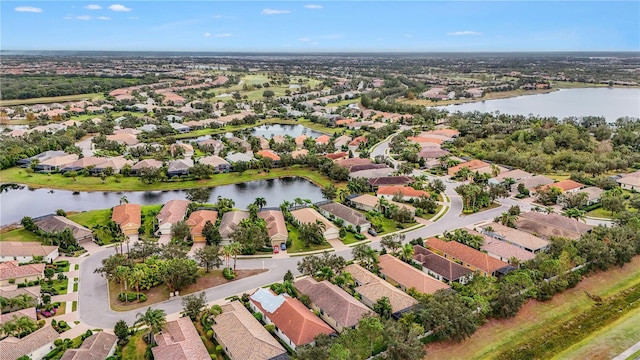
0, 75, 157, 100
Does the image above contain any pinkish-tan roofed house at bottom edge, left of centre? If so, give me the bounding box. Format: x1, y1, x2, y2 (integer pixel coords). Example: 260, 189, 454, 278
151, 317, 211, 360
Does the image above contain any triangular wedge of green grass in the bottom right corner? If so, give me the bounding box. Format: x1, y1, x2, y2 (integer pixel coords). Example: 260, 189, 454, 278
553, 308, 640, 359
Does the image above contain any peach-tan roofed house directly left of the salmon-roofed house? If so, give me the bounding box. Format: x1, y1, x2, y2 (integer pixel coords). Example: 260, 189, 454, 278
343, 264, 418, 318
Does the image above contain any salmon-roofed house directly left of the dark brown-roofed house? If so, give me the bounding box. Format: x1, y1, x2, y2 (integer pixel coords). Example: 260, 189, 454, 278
378, 254, 449, 294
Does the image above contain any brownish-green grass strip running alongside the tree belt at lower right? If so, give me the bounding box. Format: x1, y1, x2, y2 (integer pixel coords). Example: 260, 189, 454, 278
427, 256, 640, 359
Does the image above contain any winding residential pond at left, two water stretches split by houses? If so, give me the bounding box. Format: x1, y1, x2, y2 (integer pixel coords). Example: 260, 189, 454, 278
0, 177, 323, 225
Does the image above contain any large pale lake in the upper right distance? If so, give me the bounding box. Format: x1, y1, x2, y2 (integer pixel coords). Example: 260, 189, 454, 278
442, 88, 640, 122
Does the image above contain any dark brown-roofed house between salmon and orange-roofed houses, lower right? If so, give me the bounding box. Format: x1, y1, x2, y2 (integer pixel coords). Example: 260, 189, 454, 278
413, 245, 473, 284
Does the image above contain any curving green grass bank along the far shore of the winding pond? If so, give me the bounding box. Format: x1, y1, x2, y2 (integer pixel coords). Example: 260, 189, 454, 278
0, 165, 342, 191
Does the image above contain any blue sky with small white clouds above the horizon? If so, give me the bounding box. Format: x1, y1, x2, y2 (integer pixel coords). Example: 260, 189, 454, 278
0, 0, 640, 52
